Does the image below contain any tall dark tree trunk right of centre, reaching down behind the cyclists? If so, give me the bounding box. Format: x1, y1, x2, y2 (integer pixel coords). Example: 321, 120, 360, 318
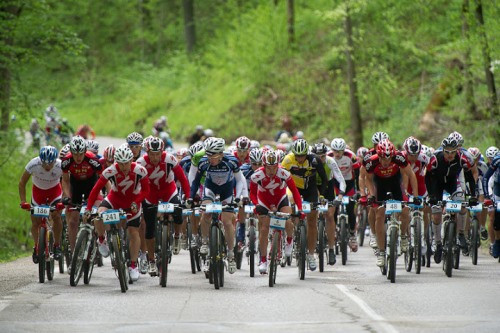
344, 4, 363, 147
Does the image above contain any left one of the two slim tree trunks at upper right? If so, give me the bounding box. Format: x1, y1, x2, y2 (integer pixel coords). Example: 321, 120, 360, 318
462, 0, 481, 120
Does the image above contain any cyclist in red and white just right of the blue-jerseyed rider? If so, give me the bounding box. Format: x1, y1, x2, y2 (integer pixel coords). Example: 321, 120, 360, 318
250, 150, 302, 274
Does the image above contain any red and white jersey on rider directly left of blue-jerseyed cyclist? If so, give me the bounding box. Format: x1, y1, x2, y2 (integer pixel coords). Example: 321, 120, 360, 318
137, 152, 190, 204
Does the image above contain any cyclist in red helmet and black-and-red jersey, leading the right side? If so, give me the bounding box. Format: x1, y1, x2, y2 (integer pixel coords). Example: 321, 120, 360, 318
365, 139, 421, 267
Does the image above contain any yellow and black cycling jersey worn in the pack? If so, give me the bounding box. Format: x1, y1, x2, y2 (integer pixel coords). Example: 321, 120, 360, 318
281, 153, 328, 195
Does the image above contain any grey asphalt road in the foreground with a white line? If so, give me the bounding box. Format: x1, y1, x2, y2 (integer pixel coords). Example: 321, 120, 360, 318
0, 240, 500, 332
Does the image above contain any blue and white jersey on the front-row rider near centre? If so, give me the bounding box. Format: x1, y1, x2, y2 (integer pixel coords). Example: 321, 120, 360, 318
191, 154, 240, 197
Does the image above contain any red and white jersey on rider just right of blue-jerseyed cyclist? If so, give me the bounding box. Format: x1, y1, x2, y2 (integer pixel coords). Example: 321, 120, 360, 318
250, 166, 302, 210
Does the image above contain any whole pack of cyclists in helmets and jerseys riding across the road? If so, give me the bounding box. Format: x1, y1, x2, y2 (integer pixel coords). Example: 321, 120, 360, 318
19, 126, 500, 281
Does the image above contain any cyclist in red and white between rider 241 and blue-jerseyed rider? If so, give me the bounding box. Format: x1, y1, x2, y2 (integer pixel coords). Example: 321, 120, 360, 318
137, 138, 190, 275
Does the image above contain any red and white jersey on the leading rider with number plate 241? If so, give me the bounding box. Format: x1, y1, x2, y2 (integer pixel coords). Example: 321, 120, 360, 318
87, 162, 149, 209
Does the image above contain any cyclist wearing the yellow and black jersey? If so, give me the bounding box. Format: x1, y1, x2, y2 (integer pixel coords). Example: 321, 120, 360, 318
281, 139, 328, 271
